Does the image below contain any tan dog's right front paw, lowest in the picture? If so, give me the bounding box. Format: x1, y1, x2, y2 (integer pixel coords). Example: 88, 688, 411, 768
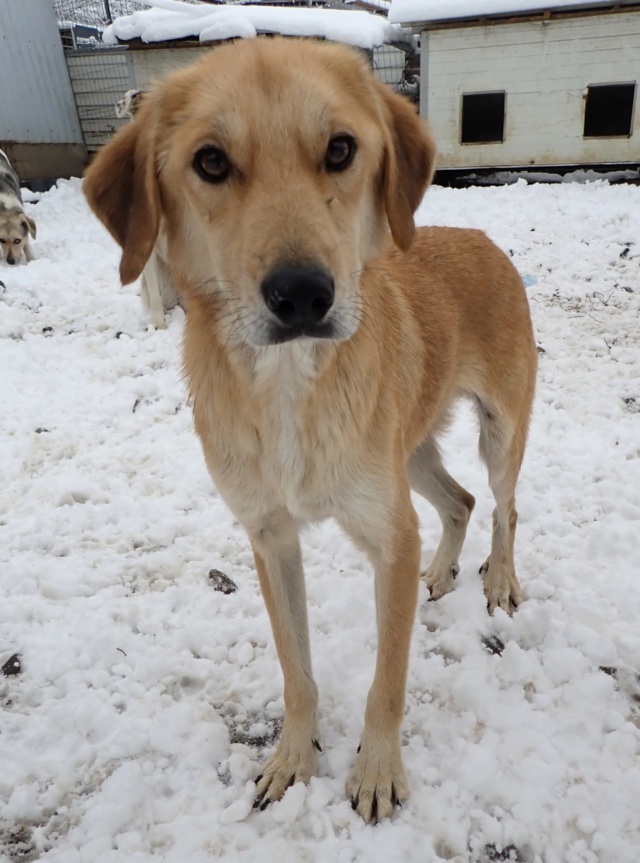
347, 741, 409, 824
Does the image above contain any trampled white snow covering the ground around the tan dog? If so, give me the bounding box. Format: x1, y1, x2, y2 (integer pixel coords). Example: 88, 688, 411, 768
0, 180, 640, 863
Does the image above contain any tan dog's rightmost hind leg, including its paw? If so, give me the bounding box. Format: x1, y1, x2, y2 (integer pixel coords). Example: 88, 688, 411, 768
476, 398, 528, 614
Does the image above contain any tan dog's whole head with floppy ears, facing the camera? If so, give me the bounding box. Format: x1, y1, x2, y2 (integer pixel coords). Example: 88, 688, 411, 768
84, 39, 435, 346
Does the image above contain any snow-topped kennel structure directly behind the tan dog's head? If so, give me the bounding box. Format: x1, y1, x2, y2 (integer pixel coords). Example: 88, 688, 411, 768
59, 0, 417, 154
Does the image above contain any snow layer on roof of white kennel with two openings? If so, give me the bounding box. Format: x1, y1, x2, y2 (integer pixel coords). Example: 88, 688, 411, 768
389, 0, 638, 24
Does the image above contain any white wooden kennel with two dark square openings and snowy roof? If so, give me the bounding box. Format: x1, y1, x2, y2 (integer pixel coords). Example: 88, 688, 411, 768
389, 0, 640, 170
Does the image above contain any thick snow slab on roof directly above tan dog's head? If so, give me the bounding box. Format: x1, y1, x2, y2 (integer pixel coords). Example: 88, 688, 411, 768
103, 0, 413, 49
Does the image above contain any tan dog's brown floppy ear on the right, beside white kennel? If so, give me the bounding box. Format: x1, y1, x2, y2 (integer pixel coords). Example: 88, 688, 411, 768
378, 84, 436, 251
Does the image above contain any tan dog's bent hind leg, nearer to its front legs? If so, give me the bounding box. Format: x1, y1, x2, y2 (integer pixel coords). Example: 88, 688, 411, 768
407, 436, 475, 599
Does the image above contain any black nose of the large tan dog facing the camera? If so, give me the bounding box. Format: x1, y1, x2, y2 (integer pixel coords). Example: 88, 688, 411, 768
262, 266, 334, 327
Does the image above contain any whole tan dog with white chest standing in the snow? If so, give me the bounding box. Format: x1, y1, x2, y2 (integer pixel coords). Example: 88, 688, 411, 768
85, 39, 537, 820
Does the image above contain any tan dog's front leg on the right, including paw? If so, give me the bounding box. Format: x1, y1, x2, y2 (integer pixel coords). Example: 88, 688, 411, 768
344, 486, 420, 822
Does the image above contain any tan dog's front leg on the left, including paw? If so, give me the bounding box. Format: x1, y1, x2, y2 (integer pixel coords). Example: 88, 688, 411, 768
249, 510, 320, 807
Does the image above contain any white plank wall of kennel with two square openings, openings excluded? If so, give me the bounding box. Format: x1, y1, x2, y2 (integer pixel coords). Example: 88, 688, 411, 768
420, 12, 640, 168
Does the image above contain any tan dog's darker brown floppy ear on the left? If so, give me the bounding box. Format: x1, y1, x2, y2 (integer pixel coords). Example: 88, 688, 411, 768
83, 105, 160, 285
